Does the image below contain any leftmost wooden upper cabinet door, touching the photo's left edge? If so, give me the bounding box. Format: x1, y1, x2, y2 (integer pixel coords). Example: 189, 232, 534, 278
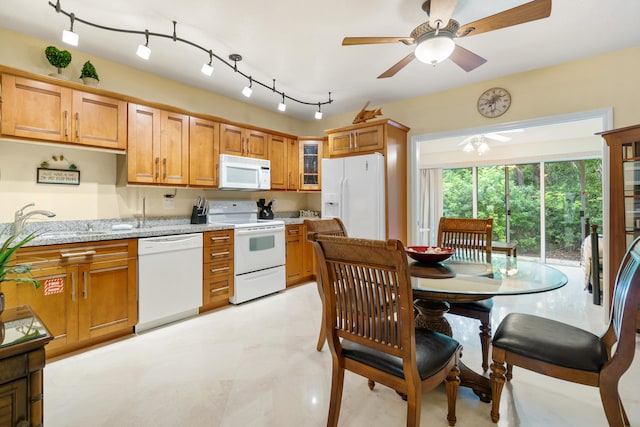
0, 74, 72, 142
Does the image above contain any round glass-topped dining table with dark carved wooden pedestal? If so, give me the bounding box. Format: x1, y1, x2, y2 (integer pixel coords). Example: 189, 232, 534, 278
409, 255, 568, 402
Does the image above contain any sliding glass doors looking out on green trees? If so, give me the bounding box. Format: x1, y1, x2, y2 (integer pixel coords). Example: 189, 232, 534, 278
442, 159, 602, 262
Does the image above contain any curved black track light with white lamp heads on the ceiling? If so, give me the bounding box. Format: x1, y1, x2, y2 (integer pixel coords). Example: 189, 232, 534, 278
49, 0, 333, 119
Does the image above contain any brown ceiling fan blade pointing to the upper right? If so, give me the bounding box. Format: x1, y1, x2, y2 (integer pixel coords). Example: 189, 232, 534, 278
457, 0, 551, 37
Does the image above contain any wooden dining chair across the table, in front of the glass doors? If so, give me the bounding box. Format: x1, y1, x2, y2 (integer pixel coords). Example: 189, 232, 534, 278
438, 217, 493, 371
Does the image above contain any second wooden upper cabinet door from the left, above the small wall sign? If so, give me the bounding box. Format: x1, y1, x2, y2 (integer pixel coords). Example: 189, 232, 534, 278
72, 91, 127, 150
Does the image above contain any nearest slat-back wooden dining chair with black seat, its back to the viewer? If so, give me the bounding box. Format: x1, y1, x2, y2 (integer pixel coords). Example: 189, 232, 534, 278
309, 233, 462, 427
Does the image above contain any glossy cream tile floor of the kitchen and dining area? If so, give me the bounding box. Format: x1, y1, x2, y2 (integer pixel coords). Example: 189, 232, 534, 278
45, 267, 640, 427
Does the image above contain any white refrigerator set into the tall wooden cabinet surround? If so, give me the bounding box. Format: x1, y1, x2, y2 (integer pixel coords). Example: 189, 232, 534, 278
321, 153, 386, 240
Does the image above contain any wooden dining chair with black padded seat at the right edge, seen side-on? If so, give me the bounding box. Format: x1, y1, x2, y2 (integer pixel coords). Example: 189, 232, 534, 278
490, 238, 640, 427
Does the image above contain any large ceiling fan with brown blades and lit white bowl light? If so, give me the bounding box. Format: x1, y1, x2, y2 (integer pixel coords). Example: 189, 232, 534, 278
342, 0, 551, 79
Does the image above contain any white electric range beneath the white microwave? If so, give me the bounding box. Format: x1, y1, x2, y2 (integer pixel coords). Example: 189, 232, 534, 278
207, 200, 286, 304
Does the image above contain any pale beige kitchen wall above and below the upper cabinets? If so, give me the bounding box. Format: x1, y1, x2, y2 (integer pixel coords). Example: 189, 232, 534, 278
0, 25, 640, 222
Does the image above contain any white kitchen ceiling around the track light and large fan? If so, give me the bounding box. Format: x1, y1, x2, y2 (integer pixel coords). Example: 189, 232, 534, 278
0, 0, 640, 120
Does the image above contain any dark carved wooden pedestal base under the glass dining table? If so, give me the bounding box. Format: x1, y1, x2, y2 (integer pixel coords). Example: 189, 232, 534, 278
413, 299, 491, 403
